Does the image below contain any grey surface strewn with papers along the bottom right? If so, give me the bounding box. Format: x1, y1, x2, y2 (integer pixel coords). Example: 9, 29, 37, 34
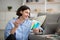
29, 33, 60, 40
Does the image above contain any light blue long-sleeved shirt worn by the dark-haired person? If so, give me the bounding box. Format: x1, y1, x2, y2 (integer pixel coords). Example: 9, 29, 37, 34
4, 19, 43, 40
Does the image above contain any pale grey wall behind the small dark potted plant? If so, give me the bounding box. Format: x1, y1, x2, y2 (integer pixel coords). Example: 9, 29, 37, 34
0, 0, 22, 11
